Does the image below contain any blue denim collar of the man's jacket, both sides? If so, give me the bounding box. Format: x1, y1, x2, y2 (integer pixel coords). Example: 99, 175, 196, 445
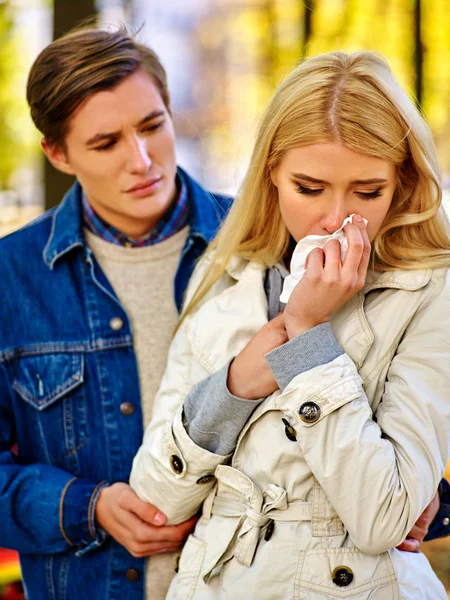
43, 168, 227, 269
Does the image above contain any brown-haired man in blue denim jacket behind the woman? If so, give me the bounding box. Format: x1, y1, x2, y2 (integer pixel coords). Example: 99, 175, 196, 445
0, 23, 448, 600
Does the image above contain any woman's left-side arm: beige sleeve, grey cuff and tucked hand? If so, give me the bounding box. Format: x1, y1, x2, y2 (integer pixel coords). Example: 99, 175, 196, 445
130, 317, 287, 524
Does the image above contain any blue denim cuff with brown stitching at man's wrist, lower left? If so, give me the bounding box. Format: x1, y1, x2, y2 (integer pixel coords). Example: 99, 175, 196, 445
59, 477, 108, 556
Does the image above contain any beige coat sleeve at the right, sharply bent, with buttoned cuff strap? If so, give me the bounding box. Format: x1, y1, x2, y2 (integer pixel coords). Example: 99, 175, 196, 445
275, 276, 450, 554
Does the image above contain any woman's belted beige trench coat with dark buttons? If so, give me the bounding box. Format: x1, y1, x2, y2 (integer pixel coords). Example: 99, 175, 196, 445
131, 259, 450, 600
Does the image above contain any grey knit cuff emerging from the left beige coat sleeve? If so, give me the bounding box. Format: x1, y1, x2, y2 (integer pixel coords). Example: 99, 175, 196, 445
184, 361, 264, 456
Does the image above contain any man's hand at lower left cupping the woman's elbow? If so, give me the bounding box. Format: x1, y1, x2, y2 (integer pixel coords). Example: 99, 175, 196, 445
95, 483, 197, 558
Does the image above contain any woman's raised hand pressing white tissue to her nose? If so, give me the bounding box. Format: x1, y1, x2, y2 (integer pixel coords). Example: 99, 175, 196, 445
284, 215, 370, 339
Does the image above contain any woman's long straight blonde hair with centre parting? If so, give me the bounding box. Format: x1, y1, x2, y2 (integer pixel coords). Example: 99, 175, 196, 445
185, 52, 450, 322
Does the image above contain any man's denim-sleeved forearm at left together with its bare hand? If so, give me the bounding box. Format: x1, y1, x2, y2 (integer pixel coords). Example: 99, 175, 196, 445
0, 364, 194, 556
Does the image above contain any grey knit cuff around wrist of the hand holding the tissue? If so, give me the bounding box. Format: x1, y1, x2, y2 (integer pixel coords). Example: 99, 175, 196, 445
265, 322, 344, 391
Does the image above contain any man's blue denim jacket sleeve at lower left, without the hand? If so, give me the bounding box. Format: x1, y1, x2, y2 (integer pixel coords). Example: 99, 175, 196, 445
0, 364, 104, 554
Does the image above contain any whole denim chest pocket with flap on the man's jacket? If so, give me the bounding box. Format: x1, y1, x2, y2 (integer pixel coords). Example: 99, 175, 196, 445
12, 353, 88, 474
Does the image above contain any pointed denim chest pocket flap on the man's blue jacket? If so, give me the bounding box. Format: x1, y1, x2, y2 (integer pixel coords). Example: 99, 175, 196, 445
13, 354, 84, 410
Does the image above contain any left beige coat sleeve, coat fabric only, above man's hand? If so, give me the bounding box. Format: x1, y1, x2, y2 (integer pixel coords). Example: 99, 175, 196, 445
130, 318, 229, 525
